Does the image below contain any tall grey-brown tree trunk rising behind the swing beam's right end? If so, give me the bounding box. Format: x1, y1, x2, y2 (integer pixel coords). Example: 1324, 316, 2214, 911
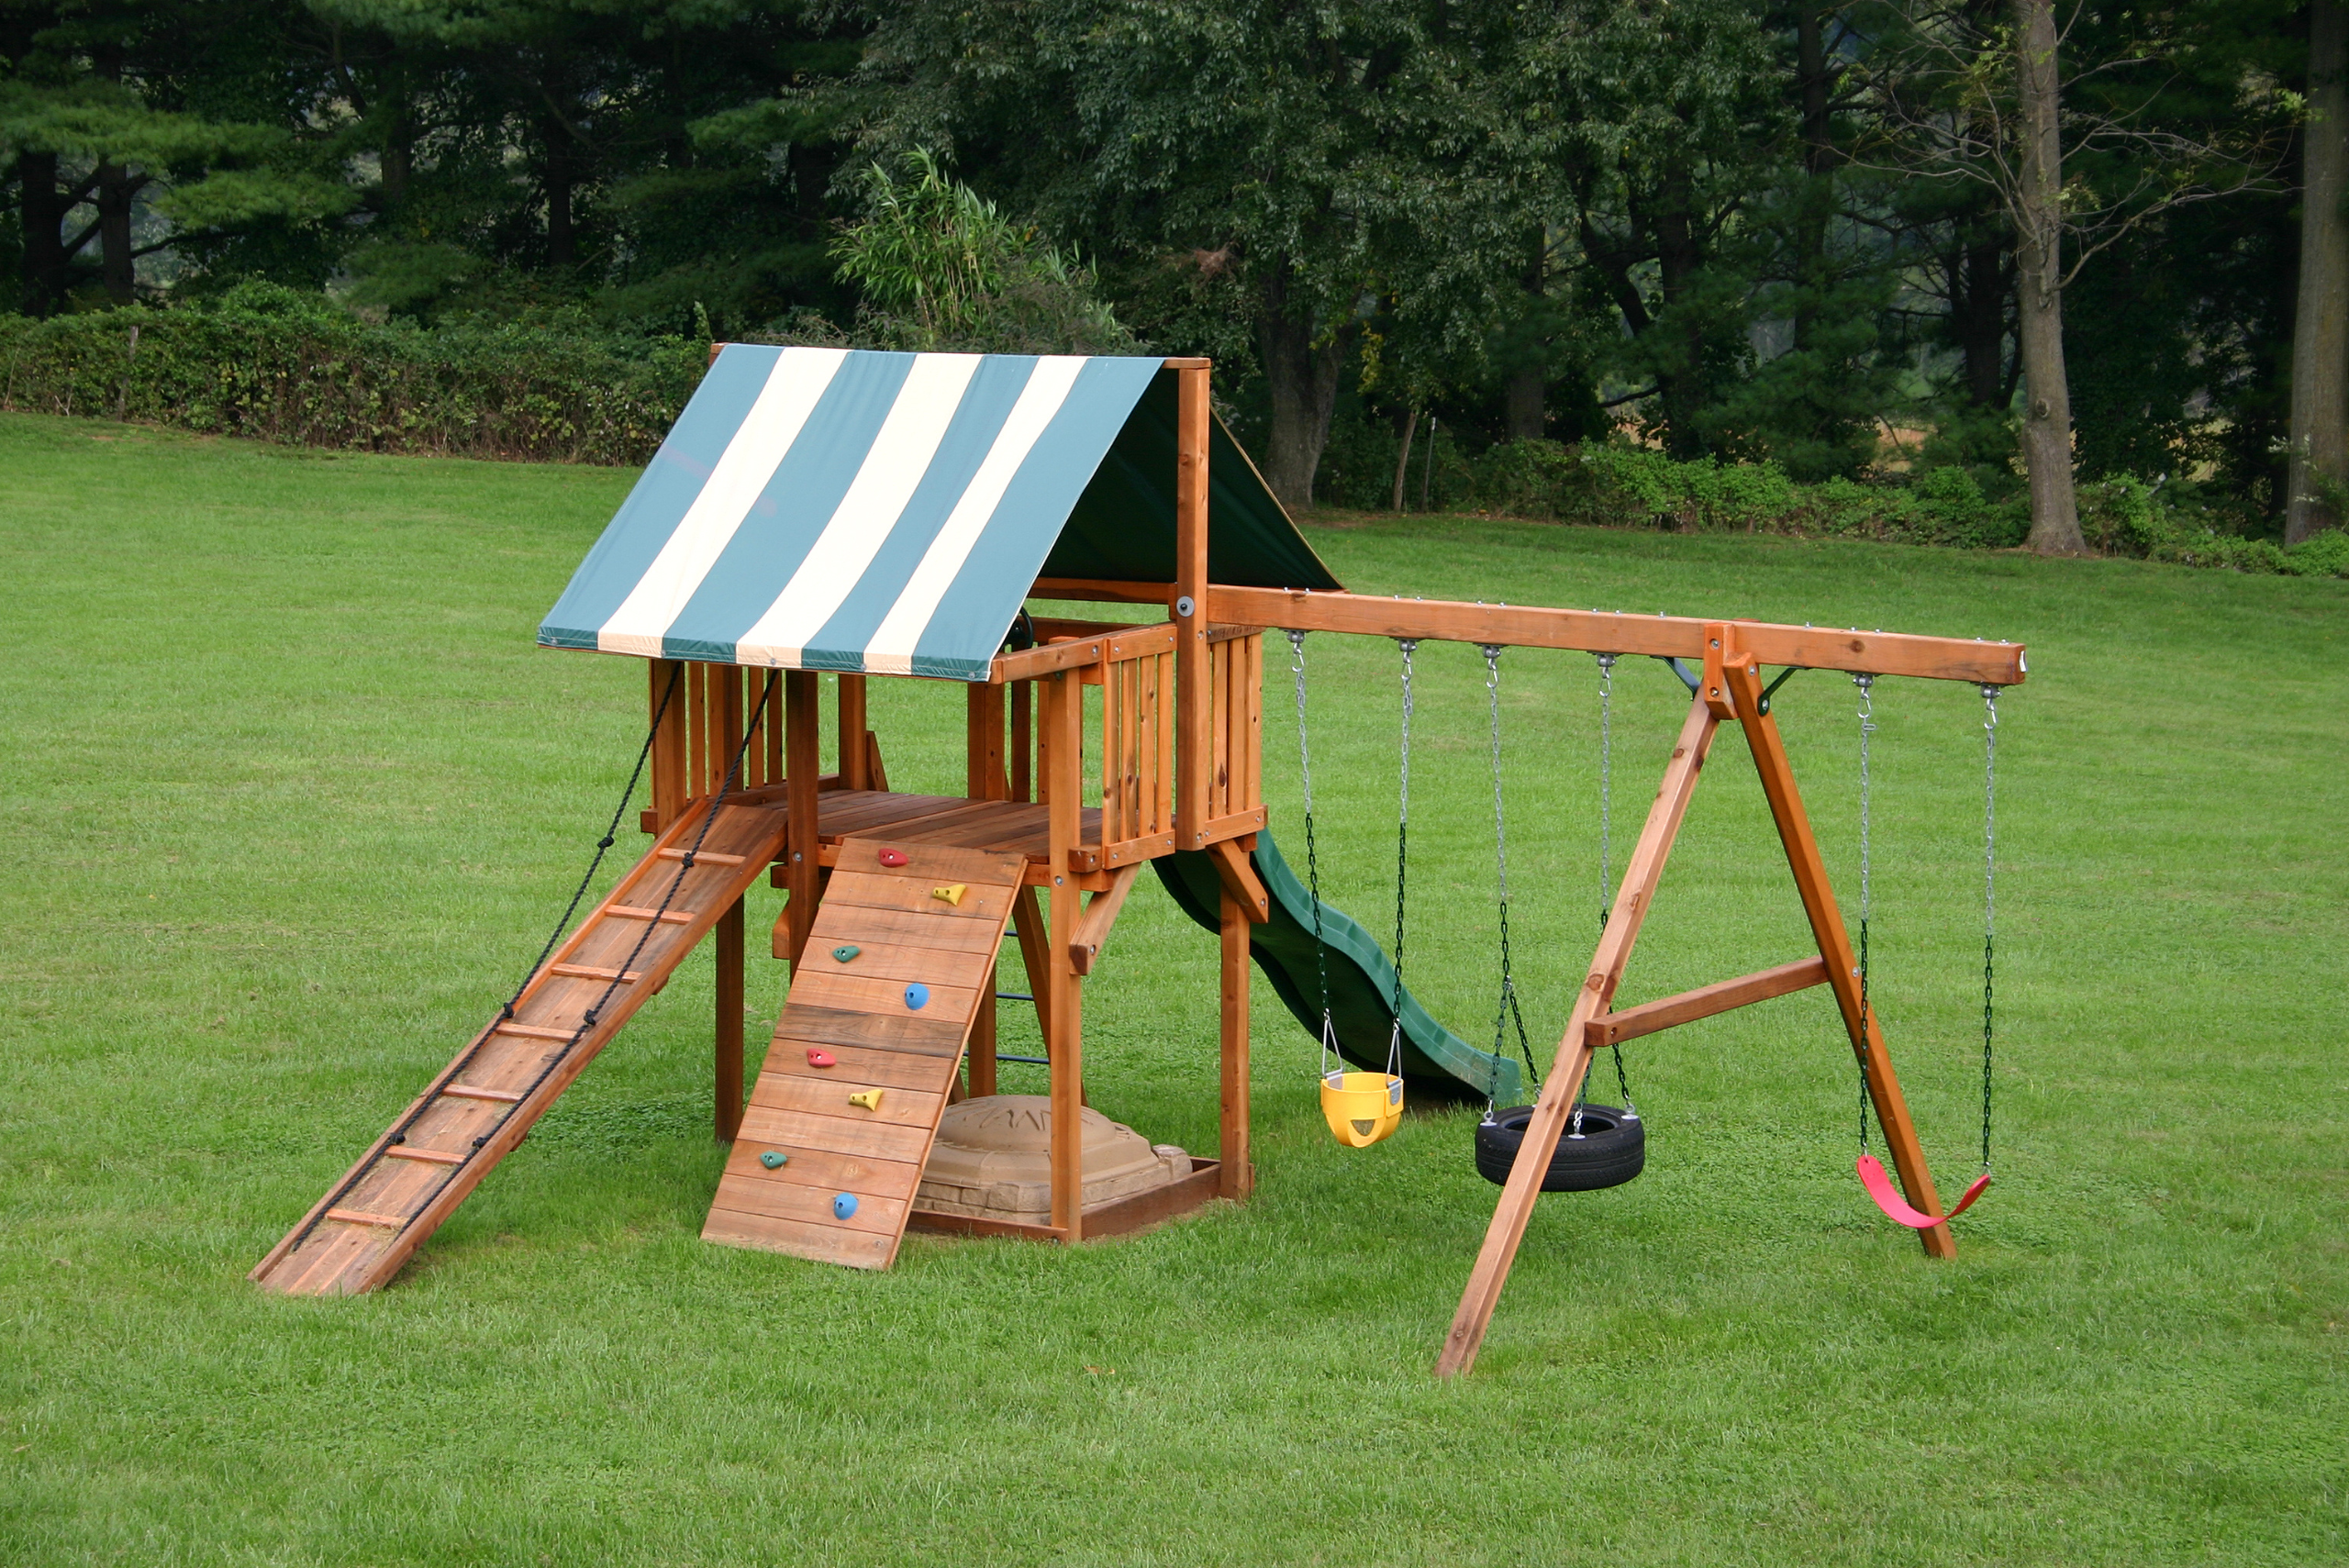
2013, 0, 2088, 556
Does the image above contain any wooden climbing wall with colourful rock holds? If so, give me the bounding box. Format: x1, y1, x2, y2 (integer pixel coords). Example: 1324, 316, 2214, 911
702, 838, 1027, 1268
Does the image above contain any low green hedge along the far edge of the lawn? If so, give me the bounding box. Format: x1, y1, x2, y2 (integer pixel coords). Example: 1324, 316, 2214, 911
0, 293, 2349, 577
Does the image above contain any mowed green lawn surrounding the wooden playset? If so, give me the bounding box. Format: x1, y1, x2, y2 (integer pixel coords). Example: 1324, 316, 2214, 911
0, 416, 2349, 1565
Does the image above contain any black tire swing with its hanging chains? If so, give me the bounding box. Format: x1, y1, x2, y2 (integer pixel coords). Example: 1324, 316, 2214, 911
1475, 643, 1647, 1193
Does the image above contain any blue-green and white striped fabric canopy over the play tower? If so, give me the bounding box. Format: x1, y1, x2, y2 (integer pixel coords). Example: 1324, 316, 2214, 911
538, 343, 1337, 681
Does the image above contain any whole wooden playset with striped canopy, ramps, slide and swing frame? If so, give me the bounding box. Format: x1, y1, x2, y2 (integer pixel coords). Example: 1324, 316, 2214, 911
253, 345, 2025, 1373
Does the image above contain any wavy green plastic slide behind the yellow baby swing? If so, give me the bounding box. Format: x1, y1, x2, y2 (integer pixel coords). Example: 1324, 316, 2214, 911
1151, 833, 1524, 1106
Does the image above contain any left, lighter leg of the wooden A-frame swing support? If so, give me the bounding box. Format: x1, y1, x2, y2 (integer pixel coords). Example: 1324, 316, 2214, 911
1435, 695, 1720, 1378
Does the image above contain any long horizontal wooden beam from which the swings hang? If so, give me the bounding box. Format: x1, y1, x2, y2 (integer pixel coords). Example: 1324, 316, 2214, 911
1208, 584, 2030, 685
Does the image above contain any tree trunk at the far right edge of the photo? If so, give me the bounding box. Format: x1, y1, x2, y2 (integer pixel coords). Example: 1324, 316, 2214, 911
2283, 0, 2349, 545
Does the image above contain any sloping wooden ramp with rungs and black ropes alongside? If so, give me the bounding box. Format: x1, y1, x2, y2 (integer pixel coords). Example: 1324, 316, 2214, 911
251, 806, 785, 1296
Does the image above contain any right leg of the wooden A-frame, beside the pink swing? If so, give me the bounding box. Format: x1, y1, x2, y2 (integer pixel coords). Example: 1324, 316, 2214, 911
1721, 655, 1956, 1258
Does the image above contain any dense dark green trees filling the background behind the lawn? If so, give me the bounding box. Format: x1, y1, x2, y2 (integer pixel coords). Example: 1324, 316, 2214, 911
0, 0, 2311, 538
